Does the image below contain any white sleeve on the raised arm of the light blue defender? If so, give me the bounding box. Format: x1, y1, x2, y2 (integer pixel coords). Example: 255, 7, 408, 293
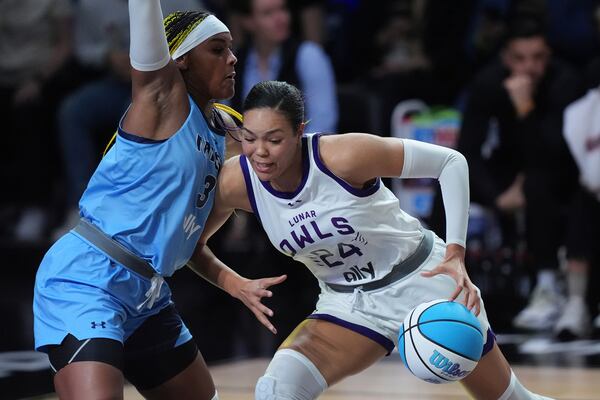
129, 0, 171, 71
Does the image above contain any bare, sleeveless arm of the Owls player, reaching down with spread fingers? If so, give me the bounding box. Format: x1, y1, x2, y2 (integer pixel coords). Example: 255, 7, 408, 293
187, 157, 286, 334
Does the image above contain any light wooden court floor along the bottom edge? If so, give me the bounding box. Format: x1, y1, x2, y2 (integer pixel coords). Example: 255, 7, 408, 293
38, 357, 600, 400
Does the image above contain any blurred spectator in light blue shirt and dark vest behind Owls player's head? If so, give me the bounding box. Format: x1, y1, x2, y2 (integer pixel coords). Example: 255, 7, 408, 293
232, 0, 338, 132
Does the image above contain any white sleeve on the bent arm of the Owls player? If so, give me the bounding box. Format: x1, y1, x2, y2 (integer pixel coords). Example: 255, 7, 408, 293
400, 139, 469, 247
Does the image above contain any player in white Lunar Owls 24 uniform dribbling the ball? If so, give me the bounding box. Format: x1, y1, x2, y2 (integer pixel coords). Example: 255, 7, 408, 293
194, 81, 546, 400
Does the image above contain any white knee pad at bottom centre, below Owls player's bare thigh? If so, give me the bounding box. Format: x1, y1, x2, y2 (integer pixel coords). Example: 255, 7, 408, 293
254, 349, 327, 400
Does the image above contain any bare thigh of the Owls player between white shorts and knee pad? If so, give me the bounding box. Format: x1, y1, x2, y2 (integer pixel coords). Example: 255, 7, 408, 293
280, 319, 387, 385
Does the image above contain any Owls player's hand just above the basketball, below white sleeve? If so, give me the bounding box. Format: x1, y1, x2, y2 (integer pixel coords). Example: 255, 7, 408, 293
421, 257, 481, 315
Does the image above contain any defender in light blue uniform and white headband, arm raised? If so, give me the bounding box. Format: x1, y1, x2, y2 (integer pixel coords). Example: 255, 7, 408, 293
34, 0, 284, 400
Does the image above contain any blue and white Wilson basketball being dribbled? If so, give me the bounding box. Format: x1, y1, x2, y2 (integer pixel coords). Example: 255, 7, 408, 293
398, 299, 484, 383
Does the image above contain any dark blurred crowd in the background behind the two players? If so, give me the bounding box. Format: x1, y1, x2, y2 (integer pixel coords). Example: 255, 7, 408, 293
0, 0, 600, 370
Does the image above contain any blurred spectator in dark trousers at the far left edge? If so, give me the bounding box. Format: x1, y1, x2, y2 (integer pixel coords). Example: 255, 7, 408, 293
0, 0, 74, 240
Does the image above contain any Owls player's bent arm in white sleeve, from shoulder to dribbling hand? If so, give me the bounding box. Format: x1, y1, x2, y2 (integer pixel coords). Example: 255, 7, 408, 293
321, 133, 479, 314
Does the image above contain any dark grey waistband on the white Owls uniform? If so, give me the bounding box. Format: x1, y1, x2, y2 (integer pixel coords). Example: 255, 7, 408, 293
326, 229, 433, 293
